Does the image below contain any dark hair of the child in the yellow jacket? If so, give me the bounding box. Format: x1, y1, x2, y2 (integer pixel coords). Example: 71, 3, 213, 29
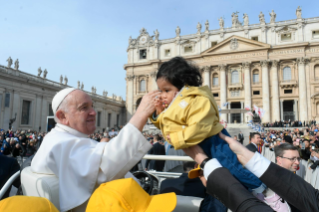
156, 57, 202, 90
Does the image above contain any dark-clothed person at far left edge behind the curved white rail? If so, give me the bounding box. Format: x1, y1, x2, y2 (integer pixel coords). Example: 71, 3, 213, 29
0, 155, 20, 200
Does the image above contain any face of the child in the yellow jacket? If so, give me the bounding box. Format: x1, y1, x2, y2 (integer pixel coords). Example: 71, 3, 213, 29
156, 78, 179, 108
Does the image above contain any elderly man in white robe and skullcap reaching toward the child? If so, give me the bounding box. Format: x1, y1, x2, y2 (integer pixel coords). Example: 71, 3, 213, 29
31, 88, 160, 211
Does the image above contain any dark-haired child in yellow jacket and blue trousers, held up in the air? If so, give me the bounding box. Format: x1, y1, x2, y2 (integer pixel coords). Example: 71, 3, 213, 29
151, 57, 292, 211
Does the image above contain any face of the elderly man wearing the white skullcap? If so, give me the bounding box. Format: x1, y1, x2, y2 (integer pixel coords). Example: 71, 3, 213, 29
65, 90, 96, 135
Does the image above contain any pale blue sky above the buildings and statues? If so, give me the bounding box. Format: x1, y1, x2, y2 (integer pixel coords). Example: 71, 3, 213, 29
0, 0, 319, 99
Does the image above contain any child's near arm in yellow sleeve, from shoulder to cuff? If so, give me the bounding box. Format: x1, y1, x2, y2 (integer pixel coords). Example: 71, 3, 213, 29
170, 97, 224, 149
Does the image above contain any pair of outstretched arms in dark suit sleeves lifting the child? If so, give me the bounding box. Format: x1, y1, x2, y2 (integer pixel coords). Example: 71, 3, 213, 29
184, 133, 319, 212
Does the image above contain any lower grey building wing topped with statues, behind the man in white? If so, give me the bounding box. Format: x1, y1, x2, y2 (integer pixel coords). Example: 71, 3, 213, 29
0, 63, 126, 132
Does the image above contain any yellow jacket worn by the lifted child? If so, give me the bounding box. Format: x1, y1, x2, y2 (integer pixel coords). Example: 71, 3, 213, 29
151, 86, 224, 149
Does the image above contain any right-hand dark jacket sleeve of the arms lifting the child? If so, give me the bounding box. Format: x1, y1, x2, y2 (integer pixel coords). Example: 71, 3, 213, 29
260, 163, 319, 212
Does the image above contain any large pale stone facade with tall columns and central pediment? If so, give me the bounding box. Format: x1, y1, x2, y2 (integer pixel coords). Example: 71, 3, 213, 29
124, 7, 319, 123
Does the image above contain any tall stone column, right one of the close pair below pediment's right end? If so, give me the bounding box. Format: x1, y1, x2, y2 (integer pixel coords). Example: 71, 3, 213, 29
271, 60, 280, 122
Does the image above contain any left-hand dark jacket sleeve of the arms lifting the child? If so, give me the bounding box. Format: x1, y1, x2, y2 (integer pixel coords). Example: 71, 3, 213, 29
206, 167, 273, 212
